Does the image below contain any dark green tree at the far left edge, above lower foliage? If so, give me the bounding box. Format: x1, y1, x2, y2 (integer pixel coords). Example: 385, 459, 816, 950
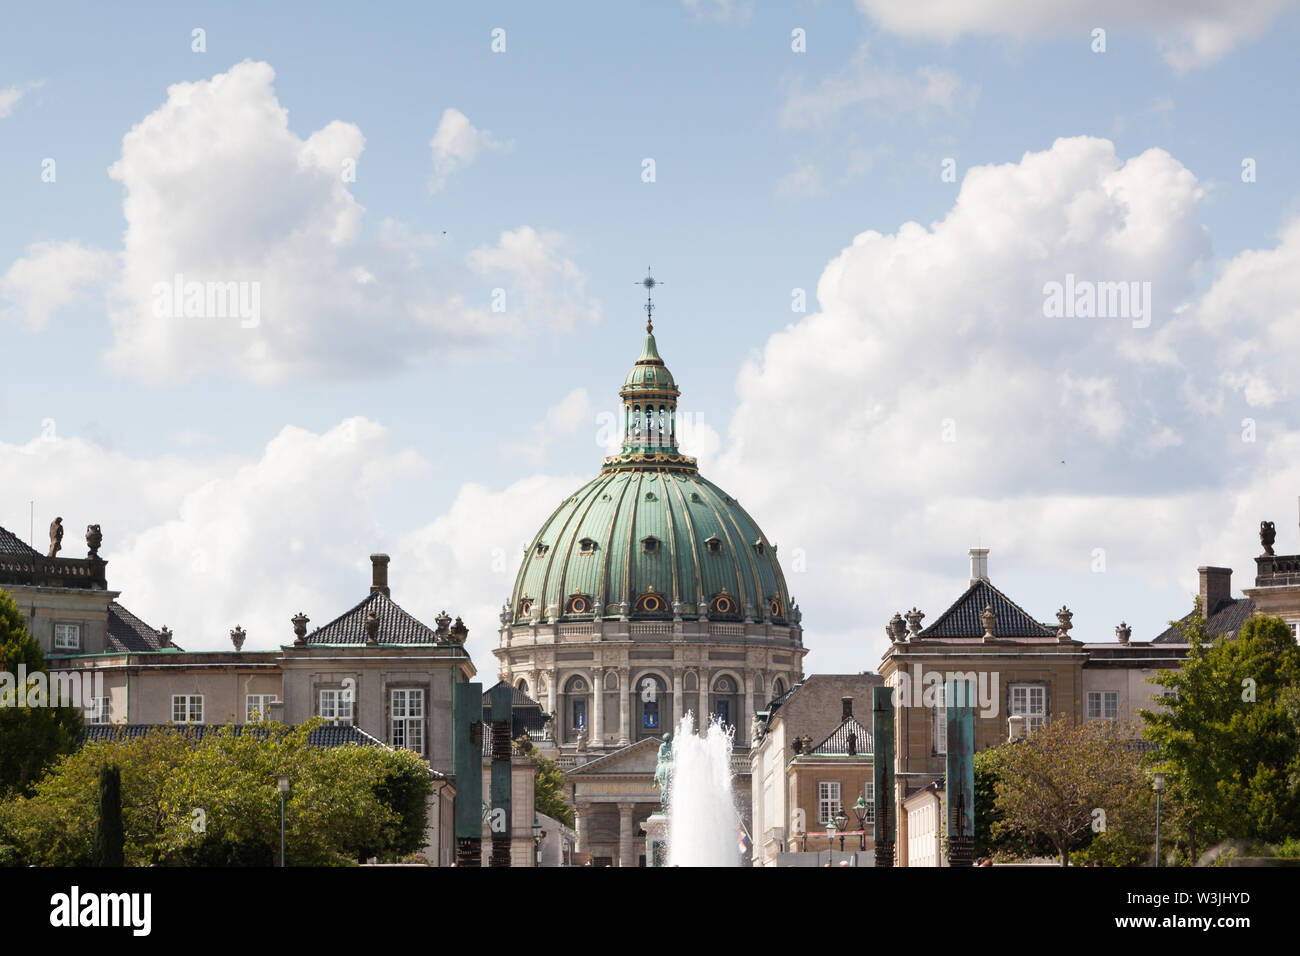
0, 591, 82, 799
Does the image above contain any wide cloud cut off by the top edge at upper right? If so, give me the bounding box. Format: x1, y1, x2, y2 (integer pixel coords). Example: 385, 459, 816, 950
858, 0, 1294, 72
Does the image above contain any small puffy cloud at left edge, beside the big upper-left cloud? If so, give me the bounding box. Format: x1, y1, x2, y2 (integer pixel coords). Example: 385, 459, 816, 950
0, 241, 117, 329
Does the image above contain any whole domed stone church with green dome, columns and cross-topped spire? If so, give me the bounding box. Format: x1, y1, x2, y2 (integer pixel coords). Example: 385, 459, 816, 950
495, 293, 806, 866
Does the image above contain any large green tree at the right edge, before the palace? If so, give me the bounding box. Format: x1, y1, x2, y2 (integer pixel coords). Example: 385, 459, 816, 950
1143, 602, 1300, 857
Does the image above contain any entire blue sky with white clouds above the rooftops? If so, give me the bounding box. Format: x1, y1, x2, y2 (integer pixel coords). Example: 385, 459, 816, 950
0, 0, 1300, 680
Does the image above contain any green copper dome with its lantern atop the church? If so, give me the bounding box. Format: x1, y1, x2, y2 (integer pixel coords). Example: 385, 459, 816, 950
503, 330, 790, 624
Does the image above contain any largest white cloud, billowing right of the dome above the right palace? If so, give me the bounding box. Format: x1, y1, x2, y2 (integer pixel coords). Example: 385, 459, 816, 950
711, 138, 1300, 670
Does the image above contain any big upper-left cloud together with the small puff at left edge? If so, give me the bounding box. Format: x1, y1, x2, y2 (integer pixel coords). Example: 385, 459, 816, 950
0, 61, 599, 382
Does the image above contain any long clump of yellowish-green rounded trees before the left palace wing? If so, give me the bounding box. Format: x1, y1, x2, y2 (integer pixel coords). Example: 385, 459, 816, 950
0, 721, 430, 866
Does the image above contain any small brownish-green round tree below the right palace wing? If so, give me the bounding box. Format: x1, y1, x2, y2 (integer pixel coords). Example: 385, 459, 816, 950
989, 714, 1151, 866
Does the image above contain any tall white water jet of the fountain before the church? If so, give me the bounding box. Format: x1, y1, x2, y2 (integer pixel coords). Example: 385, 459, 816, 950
646, 713, 741, 866
